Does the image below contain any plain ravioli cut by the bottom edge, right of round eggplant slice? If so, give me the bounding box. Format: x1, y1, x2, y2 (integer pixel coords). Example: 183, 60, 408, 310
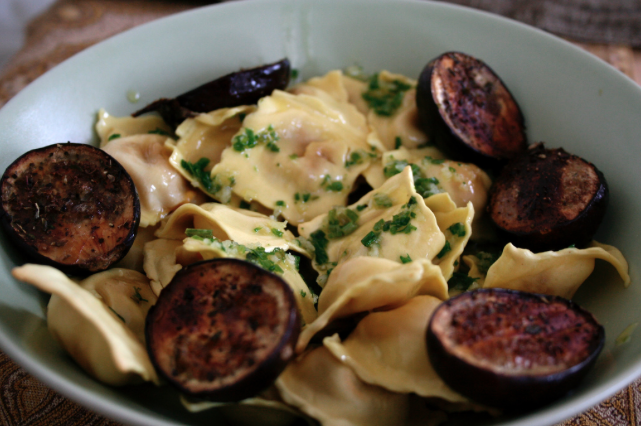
276, 347, 409, 426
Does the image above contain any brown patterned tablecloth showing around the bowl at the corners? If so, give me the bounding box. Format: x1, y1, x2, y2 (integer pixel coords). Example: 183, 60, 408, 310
0, 0, 641, 426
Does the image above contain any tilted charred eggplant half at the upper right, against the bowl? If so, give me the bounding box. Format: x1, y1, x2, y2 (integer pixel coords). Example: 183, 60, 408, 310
416, 52, 527, 168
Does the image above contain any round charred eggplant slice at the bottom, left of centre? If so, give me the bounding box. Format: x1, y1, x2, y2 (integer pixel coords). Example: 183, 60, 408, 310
145, 259, 300, 402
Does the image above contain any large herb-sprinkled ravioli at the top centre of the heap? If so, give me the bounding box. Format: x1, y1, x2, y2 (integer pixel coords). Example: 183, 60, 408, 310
211, 83, 371, 223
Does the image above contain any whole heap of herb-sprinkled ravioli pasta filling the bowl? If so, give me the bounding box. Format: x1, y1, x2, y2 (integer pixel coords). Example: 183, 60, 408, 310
6, 54, 629, 424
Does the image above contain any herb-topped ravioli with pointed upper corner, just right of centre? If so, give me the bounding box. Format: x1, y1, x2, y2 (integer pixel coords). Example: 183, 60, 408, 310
298, 167, 474, 284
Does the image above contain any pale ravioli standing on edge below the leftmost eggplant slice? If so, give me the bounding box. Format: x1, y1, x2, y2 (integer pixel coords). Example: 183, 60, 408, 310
12, 264, 159, 386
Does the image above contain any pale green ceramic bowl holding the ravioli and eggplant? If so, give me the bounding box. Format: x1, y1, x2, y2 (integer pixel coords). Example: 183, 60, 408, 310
0, 0, 641, 426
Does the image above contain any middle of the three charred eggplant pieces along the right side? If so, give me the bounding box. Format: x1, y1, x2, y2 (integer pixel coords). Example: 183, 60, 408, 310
488, 144, 609, 252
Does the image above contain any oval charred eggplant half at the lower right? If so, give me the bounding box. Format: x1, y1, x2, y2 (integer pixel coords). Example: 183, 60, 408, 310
427, 289, 605, 411
